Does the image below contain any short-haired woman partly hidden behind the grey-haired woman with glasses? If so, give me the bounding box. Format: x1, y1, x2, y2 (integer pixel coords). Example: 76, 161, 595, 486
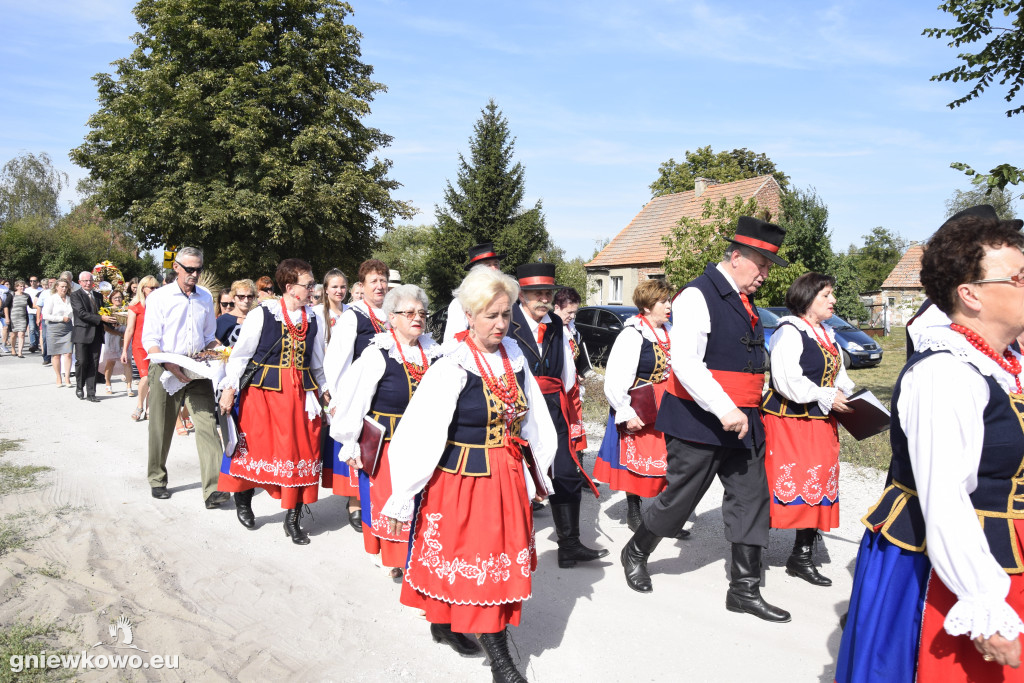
324, 259, 390, 533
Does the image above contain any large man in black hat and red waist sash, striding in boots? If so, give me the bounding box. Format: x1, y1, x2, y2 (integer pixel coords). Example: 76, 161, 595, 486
622, 216, 791, 623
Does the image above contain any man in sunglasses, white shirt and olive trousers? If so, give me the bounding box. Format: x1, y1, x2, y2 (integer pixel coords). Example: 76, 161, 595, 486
142, 247, 229, 509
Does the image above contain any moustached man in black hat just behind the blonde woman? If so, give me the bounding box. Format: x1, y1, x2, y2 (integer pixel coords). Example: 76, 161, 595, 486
509, 263, 608, 569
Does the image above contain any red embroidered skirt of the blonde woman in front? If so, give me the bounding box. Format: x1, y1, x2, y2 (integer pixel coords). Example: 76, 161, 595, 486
401, 449, 537, 633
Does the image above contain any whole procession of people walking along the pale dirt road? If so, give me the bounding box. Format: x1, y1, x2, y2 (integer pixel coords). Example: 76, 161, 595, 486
6, 205, 1024, 683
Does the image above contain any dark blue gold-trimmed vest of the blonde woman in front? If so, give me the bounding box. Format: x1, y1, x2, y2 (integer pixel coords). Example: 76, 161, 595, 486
437, 370, 526, 476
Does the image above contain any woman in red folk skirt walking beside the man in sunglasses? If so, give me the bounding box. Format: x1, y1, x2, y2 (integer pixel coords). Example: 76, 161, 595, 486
217, 258, 330, 546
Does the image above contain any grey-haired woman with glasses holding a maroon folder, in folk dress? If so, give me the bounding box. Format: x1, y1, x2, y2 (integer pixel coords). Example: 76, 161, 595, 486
331, 285, 440, 579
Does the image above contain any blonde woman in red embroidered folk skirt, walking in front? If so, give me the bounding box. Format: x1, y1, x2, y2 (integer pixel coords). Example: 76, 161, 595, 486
383, 268, 557, 681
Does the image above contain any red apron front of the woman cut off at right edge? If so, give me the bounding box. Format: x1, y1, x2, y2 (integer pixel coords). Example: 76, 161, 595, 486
918, 520, 1024, 683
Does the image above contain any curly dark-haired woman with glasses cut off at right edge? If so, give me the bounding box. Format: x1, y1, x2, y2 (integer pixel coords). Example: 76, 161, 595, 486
836, 205, 1024, 683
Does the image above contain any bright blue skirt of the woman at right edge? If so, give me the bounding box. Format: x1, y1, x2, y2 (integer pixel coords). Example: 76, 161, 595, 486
836, 530, 932, 683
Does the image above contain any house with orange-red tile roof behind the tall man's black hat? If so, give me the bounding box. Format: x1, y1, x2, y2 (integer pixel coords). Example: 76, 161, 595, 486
586, 175, 782, 305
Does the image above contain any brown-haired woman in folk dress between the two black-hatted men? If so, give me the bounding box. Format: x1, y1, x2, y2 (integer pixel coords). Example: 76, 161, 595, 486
594, 280, 689, 538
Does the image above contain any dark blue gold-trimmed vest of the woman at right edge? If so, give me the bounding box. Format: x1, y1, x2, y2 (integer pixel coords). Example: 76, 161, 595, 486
863, 350, 1024, 573
